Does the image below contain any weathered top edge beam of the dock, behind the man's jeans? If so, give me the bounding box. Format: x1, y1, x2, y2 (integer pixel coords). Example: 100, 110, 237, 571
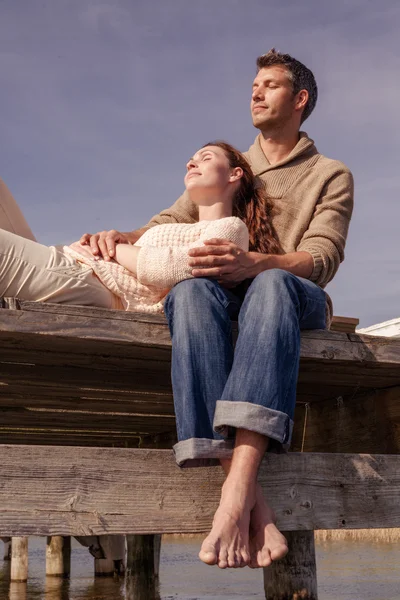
0, 303, 400, 365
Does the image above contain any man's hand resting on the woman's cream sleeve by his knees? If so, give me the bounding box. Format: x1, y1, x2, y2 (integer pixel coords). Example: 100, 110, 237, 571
189, 239, 262, 287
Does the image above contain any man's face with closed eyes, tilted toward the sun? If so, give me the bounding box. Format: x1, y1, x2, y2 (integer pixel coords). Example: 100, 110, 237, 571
250, 66, 294, 130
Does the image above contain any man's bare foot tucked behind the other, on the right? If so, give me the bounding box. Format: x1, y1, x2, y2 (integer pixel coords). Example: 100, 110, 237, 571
249, 485, 288, 569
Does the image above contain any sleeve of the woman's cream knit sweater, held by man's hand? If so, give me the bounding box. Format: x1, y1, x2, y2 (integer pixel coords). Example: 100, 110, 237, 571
137, 217, 249, 289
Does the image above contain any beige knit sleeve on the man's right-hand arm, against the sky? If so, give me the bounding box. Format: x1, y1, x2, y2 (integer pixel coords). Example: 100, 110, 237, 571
297, 163, 354, 287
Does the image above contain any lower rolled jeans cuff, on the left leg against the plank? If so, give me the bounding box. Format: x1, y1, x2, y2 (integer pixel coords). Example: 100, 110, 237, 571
173, 438, 234, 467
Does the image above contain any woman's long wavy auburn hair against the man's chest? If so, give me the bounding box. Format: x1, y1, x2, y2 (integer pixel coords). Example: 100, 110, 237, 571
203, 140, 283, 254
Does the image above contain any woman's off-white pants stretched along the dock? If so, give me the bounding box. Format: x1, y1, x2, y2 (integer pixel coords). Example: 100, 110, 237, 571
0, 179, 121, 308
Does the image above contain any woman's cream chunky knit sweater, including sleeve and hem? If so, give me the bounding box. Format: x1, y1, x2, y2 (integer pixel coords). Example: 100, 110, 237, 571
64, 217, 249, 313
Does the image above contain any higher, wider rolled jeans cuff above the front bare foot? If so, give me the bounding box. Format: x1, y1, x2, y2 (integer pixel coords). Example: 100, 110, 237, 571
214, 400, 293, 452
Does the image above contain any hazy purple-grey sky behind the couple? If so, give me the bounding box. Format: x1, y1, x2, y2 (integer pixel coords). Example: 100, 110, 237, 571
0, 0, 400, 327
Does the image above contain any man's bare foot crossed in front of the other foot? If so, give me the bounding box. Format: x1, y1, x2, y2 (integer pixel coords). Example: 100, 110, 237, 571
199, 482, 256, 569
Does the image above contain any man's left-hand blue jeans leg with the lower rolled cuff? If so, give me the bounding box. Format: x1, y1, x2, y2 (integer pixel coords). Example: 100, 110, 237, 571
165, 279, 240, 467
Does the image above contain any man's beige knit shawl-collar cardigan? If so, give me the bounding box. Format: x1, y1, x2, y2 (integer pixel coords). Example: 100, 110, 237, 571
147, 132, 353, 324
